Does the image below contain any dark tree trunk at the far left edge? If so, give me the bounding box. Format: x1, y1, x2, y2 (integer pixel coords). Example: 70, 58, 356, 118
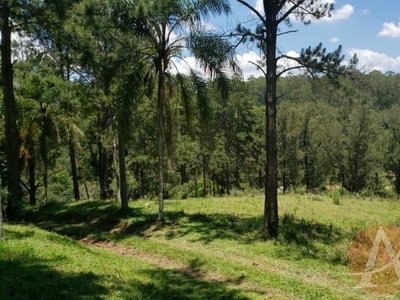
1, 0, 21, 219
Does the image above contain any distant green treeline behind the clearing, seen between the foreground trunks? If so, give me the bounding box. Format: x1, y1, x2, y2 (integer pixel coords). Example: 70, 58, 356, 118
0, 71, 400, 204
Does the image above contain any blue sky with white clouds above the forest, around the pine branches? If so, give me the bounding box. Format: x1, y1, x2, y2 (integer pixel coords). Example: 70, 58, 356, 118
177, 0, 400, 78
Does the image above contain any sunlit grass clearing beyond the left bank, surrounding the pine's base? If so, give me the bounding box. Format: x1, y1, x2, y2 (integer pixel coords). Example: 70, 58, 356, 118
18, 195, 400, 299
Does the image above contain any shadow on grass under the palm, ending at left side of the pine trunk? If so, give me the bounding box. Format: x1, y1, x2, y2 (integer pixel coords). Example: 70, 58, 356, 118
26, 201, 262, 243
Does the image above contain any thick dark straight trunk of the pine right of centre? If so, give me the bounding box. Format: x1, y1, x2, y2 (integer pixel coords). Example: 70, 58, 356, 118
264, 5, 279, 238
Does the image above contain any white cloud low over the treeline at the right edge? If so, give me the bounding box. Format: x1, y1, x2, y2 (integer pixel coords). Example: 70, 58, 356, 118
347, 48, 400, 73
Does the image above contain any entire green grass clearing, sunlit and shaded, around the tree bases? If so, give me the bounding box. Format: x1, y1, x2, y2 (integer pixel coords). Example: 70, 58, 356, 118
0, 195, 400, 299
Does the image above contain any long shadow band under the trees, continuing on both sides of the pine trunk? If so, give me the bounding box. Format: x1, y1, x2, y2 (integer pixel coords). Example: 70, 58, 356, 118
27, 201, 354, 264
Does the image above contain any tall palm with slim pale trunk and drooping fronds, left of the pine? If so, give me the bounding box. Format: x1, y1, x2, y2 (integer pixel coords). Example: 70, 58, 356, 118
120, 0, 237, 222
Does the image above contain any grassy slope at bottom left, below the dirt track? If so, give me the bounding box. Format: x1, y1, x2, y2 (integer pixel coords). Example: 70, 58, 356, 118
0, 225, 245, 300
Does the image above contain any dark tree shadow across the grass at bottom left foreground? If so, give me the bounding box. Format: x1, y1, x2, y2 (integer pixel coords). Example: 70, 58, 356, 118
0, 253, 247, 300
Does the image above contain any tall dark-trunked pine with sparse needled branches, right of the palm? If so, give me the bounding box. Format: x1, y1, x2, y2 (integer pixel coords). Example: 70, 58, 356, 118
237, 0, 343, 238
